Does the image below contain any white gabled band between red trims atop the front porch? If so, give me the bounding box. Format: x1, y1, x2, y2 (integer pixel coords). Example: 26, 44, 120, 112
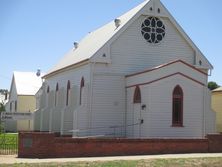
126, 60, 207, 88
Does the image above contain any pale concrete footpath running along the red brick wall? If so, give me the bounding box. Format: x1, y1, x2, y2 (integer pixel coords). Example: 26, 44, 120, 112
0, 153, 222, 165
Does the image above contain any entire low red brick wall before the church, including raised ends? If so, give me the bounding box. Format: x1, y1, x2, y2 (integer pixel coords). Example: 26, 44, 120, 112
18, 132, 222, 158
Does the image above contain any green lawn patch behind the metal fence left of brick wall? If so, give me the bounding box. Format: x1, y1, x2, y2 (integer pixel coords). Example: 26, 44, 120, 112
0, 133, 18, 154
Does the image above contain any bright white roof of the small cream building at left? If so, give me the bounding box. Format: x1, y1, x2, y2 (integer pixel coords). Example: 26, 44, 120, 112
12, 72, 42, 95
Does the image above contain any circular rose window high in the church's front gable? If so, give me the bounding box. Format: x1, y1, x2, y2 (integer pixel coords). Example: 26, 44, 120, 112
141, 17, 165, 43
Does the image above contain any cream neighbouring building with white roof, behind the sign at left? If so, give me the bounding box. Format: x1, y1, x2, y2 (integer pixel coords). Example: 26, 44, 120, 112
5, 72, 42, 131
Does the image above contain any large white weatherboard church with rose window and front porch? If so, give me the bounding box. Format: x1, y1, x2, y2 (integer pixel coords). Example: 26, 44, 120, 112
35, 0, 215, 138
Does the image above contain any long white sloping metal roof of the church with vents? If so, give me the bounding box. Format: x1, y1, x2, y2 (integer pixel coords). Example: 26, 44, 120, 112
46, 0, 150, 75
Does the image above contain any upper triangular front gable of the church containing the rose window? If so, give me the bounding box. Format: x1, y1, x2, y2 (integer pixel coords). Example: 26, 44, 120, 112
94, 0, 212, 73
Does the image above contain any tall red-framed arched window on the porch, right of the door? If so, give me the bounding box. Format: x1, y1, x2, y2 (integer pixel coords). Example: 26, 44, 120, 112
172, 85, 183, 126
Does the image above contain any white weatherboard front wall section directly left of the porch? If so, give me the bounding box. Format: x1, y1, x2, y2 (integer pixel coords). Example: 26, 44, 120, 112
91, 74, 126, 136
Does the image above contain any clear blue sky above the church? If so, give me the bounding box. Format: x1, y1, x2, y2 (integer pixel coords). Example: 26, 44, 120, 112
0, 0, 222, 89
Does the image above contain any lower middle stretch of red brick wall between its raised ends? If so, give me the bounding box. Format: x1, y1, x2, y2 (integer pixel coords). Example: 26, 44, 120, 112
51, 138, 208, 157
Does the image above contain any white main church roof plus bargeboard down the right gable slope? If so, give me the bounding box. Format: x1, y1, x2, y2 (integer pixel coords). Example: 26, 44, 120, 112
44, 0, 213, 78
